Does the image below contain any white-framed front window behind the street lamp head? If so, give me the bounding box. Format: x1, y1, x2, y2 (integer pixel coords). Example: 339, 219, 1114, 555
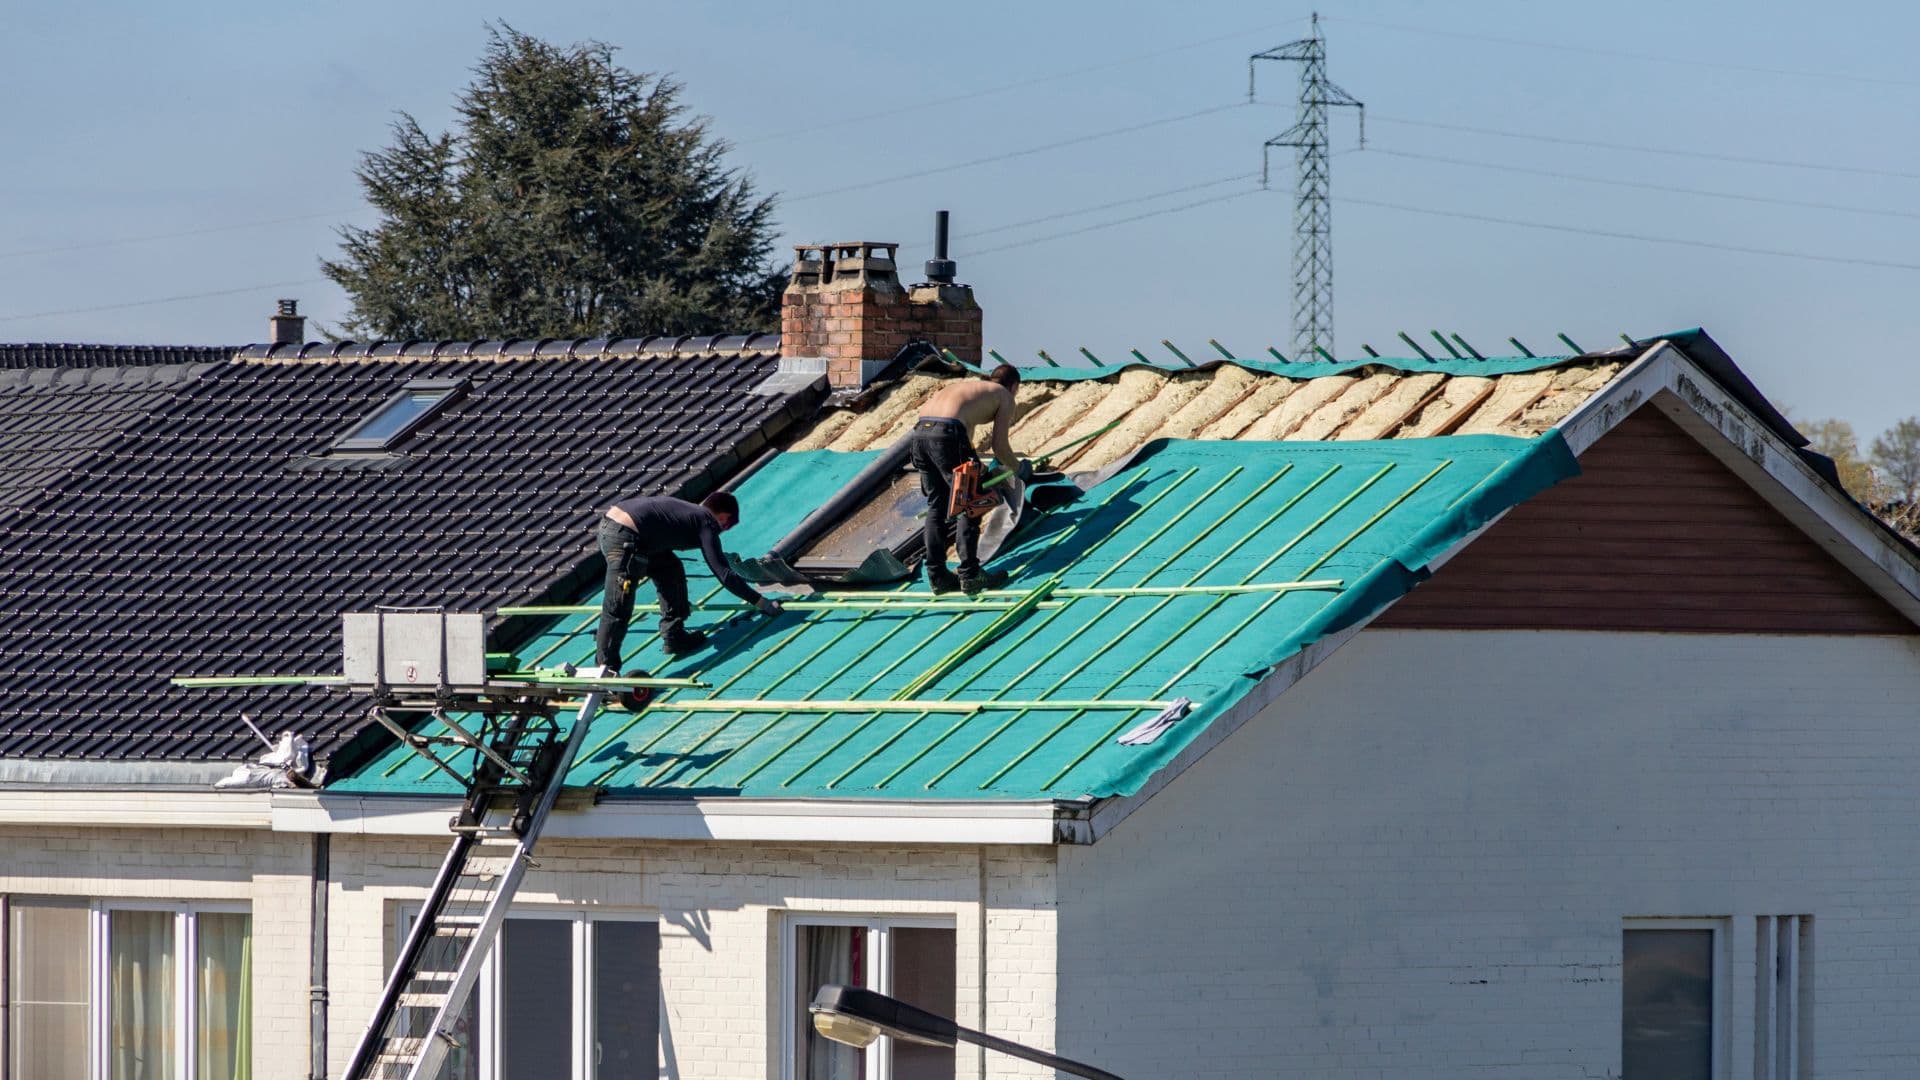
781, 915, 956, 1080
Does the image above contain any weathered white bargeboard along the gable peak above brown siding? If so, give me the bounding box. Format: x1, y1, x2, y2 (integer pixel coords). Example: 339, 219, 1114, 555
1561, 342, 1920, 623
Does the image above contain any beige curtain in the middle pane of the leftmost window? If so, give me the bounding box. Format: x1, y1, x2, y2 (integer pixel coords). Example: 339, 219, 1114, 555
108, 911, 175, 1080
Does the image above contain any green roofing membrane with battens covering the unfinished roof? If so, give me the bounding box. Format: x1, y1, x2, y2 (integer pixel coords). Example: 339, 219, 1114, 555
328, 432, 1578, 799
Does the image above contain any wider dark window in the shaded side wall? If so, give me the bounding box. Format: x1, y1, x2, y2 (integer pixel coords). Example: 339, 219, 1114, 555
1620, 919, 1724, 1080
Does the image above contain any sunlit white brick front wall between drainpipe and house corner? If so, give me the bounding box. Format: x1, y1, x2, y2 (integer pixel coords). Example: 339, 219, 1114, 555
328, 836, 1054, 1080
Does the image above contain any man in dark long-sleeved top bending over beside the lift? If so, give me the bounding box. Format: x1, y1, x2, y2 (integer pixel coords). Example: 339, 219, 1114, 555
593, 492, 780, 673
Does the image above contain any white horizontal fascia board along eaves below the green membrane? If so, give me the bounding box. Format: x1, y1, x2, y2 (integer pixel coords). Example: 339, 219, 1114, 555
273, 792, 1087, 844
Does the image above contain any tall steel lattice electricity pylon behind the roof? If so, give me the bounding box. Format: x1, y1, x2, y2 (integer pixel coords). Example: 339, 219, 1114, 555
1246, 12, 1367, 359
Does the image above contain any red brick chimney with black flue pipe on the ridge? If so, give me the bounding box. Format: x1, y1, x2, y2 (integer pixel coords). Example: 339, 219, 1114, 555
780, 209, 981, 390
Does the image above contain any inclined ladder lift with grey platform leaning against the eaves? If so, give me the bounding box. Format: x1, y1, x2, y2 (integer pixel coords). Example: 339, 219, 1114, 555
346, 611, 605, 1080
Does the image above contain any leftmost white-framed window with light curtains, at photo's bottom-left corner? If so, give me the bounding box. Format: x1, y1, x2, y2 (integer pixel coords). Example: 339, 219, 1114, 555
6, 897, 253, 1080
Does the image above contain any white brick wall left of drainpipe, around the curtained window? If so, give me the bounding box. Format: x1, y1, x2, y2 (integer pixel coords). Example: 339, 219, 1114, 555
0, 824, 313, 1080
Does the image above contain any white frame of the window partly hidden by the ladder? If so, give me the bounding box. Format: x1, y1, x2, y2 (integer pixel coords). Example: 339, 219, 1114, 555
394, 901, 666, 1080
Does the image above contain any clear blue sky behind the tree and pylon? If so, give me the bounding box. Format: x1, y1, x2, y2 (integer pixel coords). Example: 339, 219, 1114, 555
0, 0, 1920, 436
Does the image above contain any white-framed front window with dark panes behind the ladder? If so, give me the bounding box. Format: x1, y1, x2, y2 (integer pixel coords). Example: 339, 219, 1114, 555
396, 911, 660, 1080
